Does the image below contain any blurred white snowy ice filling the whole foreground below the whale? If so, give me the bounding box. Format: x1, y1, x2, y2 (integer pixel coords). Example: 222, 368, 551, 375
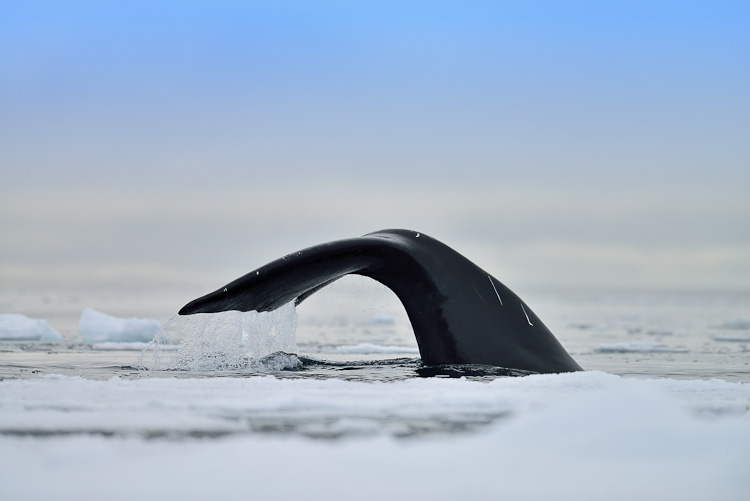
0, 372, 750, 500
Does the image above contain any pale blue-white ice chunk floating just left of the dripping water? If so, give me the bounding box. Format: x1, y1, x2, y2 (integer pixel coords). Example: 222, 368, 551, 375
78, 308, 161, 343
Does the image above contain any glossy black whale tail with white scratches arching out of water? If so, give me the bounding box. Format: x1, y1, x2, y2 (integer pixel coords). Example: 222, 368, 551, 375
179, 230, 582, 373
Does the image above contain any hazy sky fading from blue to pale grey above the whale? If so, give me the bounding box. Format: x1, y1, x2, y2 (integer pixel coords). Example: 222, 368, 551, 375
0, 0, 750, 290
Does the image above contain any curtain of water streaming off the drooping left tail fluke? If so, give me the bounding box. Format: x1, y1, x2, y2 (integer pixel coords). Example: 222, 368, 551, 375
138, 302, 301, 371
